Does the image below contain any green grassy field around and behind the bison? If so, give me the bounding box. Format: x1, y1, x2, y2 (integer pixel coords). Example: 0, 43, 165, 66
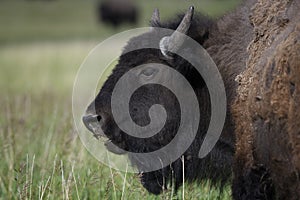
0, 0, 237, 200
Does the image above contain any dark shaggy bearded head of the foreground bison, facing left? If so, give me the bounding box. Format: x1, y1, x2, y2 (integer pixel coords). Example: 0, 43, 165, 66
83, 7, 233, 194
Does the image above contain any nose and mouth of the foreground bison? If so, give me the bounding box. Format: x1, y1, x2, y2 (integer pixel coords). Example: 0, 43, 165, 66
82, 115, 126, 155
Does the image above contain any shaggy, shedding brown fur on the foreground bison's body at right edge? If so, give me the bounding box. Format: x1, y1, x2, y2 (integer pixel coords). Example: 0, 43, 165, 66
233, 0, 300, 199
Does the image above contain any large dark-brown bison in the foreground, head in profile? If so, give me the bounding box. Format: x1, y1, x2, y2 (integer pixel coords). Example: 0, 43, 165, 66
83, 0, 300, 199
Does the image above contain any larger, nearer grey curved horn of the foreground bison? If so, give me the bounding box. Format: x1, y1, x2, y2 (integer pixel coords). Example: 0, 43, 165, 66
159, 6, 194, 58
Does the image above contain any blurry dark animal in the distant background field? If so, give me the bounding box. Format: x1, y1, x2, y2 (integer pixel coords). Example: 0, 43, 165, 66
97, 0, 138, 27
